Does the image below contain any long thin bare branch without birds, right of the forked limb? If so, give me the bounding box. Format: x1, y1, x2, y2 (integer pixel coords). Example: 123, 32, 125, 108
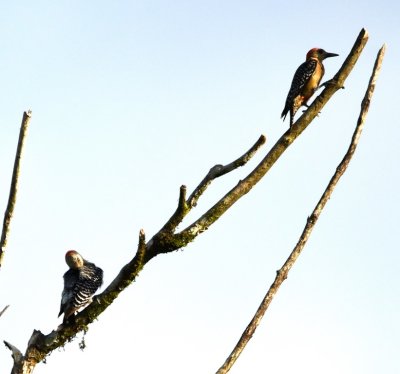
216, 45, 386, 374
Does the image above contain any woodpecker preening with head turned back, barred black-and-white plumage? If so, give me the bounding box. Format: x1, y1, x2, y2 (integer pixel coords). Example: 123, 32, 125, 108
58, 250, 103, 323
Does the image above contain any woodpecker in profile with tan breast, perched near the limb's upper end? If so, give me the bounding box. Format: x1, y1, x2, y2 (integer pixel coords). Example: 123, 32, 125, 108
281, 48, 339, 127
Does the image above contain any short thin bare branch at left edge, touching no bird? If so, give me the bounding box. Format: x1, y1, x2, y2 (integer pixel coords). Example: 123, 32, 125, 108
0, 110, 32, 269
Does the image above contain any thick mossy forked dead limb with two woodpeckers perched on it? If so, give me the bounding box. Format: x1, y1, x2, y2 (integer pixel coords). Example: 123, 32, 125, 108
3, 29, 368, 373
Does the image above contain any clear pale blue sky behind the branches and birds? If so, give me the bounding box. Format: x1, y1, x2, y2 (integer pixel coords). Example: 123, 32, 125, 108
0, 0, 400, 374
